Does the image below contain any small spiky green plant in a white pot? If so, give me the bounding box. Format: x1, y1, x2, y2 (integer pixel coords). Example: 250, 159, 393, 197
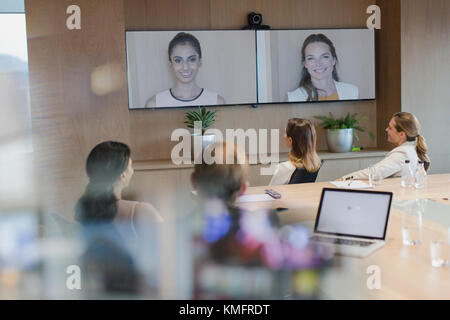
184, 107, 216, 150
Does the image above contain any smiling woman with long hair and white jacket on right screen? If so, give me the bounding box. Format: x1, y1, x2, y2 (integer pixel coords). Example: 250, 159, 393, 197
287, 33, 359, 102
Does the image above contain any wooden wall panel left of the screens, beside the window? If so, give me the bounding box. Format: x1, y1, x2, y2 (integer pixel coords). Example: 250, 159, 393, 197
25, 0, 129, 216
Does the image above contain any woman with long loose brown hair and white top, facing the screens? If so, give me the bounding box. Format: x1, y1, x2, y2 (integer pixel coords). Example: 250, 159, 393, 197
269, 118, 322, 185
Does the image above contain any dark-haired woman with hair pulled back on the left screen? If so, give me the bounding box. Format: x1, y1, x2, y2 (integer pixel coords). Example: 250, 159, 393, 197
145, 32, 225, 108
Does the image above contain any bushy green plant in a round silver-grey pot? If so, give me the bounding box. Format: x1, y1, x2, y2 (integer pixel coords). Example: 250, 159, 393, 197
314, 112, 375, 152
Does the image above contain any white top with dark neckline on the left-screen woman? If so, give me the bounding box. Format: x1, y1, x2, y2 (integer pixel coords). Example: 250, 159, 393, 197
156, 89, 218, 108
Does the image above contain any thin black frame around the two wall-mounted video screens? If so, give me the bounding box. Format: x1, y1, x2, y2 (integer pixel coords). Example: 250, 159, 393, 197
125, 27, 377, 111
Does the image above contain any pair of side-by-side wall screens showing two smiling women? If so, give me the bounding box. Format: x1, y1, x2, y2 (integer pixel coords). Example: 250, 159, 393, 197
126, 29, 375, 109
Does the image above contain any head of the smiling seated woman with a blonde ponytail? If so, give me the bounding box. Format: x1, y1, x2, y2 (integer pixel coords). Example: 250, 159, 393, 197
386, 112, 430, 168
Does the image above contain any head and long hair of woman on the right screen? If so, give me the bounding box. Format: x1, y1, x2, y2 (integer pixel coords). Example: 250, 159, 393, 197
300, 33, 339, 101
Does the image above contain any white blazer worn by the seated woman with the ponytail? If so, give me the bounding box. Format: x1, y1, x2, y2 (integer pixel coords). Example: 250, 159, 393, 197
342, 141, 419, 180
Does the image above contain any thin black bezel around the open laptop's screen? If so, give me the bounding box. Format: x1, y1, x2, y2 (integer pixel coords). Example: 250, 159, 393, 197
314, 188, 393, 240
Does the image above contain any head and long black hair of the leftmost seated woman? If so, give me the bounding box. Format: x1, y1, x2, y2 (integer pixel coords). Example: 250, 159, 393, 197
76, 141, 134, 223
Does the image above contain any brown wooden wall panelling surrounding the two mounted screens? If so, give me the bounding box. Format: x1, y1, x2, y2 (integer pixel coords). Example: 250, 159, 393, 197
25, 0, 400, 217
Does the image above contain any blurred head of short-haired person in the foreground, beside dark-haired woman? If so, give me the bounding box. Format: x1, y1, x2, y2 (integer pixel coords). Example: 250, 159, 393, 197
192, 142, 248, 206
